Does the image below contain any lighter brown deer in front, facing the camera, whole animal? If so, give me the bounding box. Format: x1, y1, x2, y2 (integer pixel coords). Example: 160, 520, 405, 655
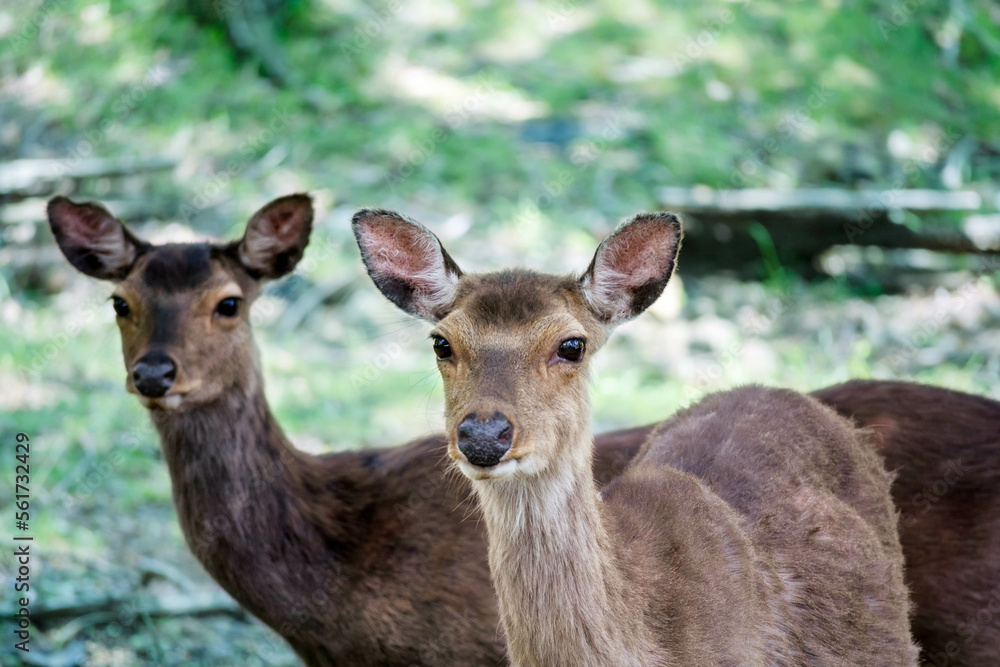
354, 210, 917, 667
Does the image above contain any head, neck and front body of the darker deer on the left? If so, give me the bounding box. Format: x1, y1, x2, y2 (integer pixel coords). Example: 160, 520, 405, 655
49, 195, 649, 666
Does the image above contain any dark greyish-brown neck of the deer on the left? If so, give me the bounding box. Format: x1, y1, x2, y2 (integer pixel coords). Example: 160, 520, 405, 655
146, 360, 357, 608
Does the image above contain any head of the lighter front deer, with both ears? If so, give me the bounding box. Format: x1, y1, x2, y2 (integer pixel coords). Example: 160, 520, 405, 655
353, 210, 681, 479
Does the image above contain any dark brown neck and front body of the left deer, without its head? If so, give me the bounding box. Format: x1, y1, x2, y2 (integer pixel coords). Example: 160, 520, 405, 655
154, 392, 649, 667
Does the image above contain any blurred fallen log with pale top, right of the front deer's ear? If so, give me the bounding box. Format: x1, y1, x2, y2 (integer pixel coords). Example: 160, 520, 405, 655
659, 186, 1000, 274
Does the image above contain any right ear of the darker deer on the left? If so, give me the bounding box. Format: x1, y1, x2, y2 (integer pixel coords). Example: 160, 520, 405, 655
236, 194, 313, 278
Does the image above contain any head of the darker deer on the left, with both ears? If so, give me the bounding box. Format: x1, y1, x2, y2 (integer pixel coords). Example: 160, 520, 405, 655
48, 194, 313, 410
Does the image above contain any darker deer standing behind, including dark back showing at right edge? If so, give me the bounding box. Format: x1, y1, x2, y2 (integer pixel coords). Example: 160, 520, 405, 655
48, 194, 1000, 666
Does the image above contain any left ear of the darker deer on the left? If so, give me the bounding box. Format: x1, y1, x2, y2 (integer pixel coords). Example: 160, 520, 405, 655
48, 197, 146, 280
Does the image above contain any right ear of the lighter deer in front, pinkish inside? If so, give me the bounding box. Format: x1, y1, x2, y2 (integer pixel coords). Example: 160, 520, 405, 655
580, 213, 682, 324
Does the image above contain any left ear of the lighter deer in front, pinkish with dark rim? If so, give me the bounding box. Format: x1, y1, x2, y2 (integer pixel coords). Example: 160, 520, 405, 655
351, 209, 462, 322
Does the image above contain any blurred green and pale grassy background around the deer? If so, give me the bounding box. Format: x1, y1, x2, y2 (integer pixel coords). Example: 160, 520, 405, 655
0, 0, 1000, 667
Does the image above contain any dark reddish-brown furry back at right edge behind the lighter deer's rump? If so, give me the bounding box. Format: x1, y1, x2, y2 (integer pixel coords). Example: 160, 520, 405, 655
813, 380, 1000, 667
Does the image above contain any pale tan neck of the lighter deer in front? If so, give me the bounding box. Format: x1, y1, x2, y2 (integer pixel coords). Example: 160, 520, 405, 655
474, 429, 649, 666
